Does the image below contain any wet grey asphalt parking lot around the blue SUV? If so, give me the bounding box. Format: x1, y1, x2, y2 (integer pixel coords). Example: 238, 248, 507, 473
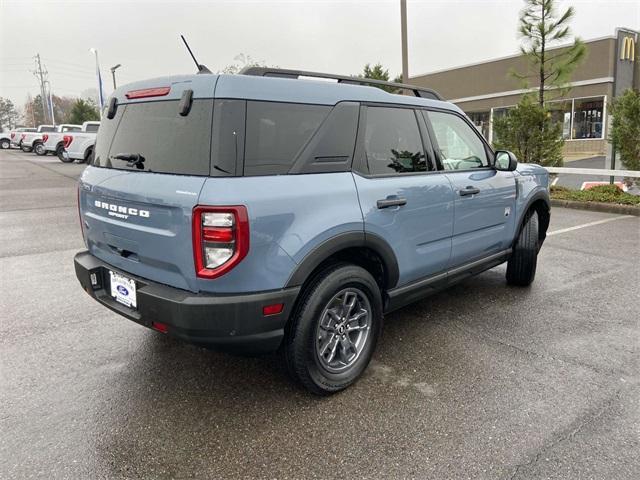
0, 150, 640, 479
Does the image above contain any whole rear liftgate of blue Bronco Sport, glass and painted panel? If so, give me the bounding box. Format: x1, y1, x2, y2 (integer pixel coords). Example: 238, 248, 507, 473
78, 76, 215, 291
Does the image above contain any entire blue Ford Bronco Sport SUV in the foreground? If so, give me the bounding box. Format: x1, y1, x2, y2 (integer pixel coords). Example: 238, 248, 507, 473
75, 68, 550, 394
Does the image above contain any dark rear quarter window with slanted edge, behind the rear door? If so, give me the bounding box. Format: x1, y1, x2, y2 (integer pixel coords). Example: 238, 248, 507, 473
244, 102, 331, 175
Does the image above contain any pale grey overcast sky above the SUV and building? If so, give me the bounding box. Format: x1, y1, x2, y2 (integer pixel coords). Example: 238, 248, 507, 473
0, 0, 640, 106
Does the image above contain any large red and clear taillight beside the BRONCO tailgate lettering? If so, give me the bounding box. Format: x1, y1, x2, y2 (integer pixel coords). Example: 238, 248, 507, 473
193, 205, 249, 279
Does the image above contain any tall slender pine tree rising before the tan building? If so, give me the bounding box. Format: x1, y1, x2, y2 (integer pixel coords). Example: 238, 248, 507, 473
514, 0, 587, 107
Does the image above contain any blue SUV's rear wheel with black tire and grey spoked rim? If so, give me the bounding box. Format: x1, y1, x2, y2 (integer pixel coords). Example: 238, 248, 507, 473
283, 264, 382, 395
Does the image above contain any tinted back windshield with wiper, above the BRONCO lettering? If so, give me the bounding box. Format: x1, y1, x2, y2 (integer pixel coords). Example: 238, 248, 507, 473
93, 100, 213, 175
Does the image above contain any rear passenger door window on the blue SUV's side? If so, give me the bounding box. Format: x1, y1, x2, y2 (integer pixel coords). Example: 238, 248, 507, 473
364, 107, 429, 175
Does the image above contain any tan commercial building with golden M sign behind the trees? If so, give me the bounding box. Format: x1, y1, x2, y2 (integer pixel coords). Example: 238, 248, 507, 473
410, 28, 640, 157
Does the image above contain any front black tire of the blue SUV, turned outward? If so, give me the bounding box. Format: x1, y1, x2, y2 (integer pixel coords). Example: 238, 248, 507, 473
507, 211, 539, 287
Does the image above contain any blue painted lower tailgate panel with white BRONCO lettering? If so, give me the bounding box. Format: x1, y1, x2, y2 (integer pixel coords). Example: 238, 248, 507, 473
79, 167, 205, 291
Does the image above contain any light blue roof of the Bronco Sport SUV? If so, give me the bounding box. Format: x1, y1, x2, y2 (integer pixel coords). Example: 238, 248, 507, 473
113, 75, 460, 112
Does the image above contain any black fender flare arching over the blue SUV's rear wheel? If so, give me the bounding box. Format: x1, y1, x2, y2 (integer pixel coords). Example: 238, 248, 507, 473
285, 231, 400, 288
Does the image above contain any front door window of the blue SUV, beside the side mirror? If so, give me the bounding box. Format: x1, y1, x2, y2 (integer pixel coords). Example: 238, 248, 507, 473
423, 112, 489, 170
